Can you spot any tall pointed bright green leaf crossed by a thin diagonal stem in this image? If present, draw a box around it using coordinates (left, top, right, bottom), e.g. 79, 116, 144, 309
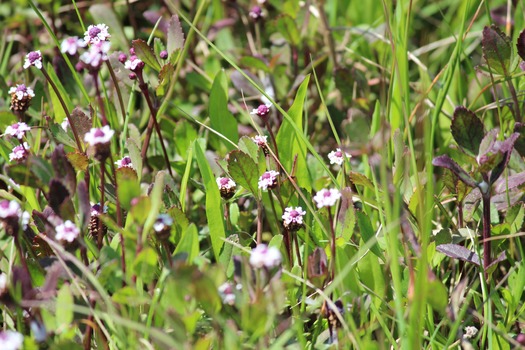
277, 75, 312, 191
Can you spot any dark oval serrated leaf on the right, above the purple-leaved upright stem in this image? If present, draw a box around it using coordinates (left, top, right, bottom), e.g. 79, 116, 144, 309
450, 106, 485, 156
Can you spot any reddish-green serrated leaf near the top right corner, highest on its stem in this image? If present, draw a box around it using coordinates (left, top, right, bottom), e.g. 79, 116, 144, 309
481, 25, 512, 76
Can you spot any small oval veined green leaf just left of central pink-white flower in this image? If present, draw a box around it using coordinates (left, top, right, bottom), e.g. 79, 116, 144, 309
228, 151, 259, 196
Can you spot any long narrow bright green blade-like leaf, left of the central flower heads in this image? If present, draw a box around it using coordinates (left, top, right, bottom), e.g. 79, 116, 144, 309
193, 140, 226, 260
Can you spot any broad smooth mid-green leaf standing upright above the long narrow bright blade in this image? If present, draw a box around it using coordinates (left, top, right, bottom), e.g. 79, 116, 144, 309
208, 70, 239, 151
